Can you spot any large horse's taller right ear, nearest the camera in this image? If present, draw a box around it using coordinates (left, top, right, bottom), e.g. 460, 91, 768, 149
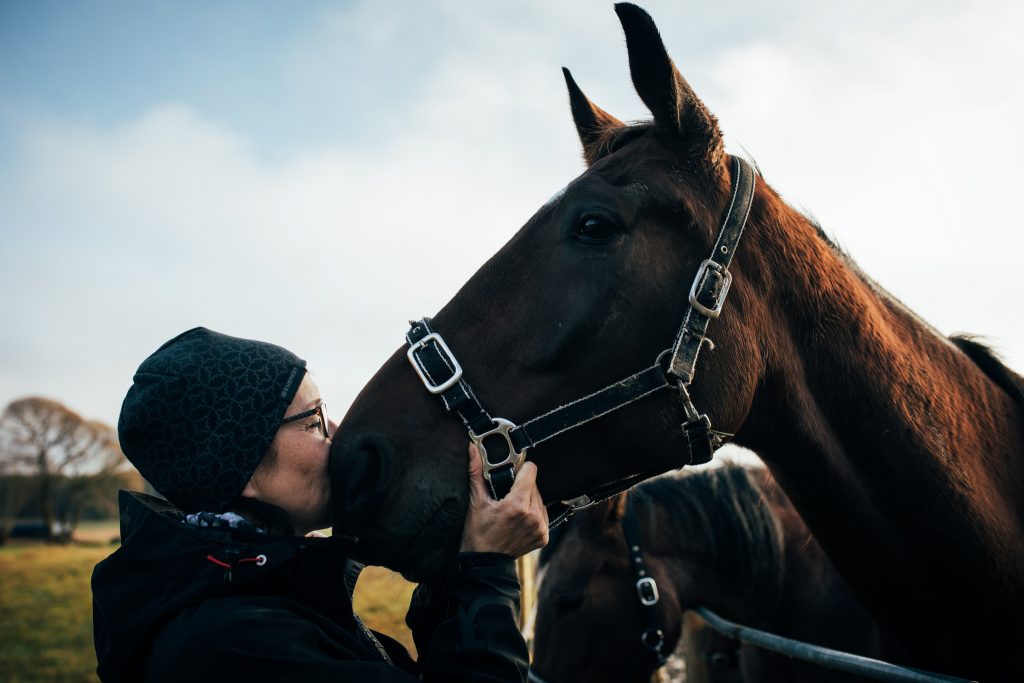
615, 2, 724, 166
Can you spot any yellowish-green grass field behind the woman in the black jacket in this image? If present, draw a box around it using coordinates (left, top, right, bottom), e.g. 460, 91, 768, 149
0, 522, 414, 683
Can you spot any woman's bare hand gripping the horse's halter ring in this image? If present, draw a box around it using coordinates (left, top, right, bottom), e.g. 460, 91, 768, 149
459, 443, 548, 557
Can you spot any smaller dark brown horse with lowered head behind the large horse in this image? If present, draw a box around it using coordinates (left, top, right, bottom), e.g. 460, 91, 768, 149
530, 466, 880, 683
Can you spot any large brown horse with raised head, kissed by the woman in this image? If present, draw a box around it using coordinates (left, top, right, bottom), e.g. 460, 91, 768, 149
332, 4, 1024, 680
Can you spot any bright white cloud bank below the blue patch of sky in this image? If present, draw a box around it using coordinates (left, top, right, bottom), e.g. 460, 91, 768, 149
0, 3, 1024, 428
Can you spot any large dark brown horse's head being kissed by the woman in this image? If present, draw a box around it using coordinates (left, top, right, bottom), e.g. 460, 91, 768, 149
332, 4, 764, 578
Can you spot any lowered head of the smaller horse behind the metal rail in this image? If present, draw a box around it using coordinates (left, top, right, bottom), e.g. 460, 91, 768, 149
530, 494, 683, 683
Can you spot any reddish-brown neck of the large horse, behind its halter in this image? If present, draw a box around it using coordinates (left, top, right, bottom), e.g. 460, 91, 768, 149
737, 208, 1024, 667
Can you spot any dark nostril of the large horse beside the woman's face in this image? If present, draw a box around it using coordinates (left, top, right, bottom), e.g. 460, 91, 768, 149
331, 439, 386, 535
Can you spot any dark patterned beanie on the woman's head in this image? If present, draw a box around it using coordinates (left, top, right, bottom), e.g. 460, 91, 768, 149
118, 328, 306, 512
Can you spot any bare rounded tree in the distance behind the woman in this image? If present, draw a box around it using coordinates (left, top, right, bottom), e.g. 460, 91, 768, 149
0, 396, 125, 540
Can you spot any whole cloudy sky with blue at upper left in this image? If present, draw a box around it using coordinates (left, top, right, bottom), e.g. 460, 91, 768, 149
0, 0, 1024, 424
